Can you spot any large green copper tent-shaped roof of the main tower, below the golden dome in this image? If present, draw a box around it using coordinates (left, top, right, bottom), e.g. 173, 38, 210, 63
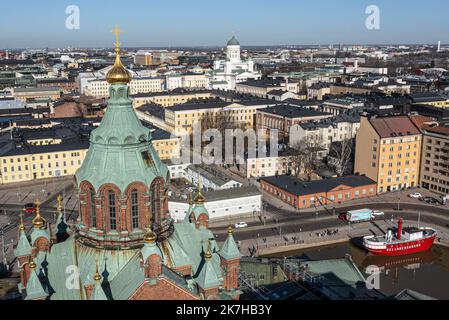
75, 85, 168, 192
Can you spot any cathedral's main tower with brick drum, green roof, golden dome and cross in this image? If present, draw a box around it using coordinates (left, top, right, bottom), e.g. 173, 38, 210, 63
75, 28, 169, 247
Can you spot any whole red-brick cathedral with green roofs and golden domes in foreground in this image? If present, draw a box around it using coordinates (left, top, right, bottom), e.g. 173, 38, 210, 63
14, 28, 241, 300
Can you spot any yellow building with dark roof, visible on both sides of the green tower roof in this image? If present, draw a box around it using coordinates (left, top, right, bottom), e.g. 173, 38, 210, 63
0, 122, 181, 184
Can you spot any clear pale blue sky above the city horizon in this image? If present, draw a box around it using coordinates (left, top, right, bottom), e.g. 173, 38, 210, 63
0, 0, 449, 49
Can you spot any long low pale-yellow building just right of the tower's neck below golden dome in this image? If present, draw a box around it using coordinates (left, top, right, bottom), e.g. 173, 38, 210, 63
131, 90, 211, 108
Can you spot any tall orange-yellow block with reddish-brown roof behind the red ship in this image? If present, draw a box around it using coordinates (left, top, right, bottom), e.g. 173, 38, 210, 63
354, 116, 422, 193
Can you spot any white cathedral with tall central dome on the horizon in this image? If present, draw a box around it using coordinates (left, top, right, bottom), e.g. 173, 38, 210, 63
208, 36, 262, 90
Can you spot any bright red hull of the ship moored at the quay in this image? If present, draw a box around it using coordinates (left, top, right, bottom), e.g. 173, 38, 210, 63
364, 235, 436, 256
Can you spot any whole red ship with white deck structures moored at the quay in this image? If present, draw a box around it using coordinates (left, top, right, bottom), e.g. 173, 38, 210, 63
363, 218, 437, 256
